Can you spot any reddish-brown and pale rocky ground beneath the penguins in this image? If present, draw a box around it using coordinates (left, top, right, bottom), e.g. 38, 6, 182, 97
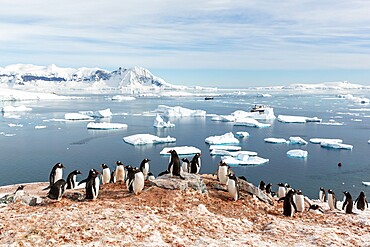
0, 175, 370, 246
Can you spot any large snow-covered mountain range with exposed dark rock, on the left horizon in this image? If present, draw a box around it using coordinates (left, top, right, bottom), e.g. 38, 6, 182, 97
0, 64, 186, 93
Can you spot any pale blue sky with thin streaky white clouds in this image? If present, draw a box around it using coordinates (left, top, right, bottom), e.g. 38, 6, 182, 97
0, 0, 370, 87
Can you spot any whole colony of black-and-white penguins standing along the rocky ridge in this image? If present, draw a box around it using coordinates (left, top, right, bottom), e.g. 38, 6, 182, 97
39, 153, 368, 216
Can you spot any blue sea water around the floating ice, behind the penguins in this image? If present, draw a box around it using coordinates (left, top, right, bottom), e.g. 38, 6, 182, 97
0, 94, 370, 198
